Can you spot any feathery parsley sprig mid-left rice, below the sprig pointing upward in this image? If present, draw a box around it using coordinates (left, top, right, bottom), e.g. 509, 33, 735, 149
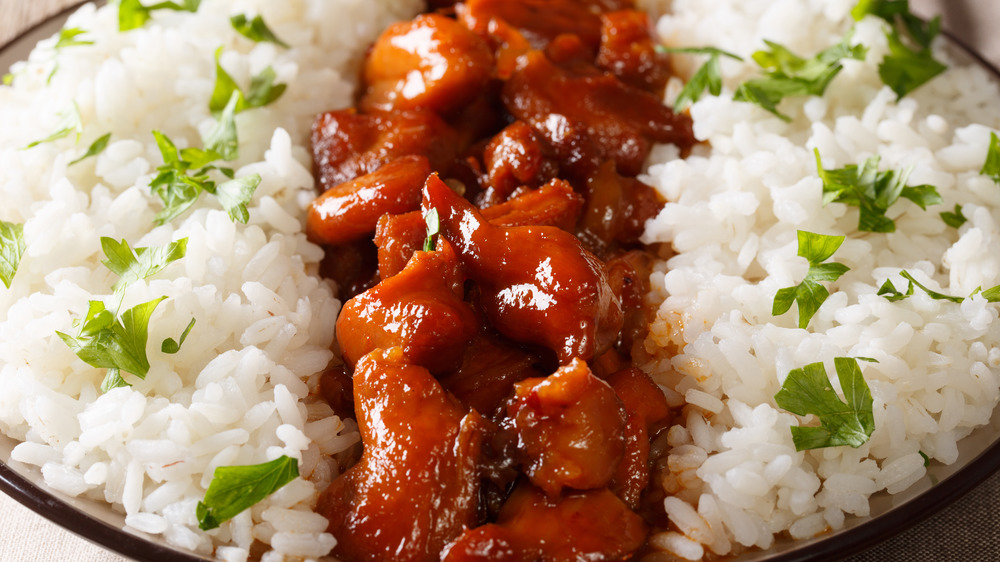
149, 131, 261, 224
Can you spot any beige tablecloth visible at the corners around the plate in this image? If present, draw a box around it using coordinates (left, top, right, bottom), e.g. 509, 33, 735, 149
0, 0, 1000, 562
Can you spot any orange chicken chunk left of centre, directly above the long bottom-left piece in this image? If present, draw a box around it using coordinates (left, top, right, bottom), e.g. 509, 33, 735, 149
337, 243, 479, 373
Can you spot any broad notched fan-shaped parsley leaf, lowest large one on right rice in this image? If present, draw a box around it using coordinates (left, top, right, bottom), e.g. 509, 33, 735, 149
774, 357, 875, 451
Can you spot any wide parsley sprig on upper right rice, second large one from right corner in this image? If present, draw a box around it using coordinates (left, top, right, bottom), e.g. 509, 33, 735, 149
733, 33, 868, 121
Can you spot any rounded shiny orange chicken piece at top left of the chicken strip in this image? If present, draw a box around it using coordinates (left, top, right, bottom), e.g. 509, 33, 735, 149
361, 14, 493, 115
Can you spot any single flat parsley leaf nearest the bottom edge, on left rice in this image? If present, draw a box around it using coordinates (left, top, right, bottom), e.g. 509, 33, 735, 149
195, 455, 299, 531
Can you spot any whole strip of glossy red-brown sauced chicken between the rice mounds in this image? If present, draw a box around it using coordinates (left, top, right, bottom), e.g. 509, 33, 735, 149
307, 0, 695, 562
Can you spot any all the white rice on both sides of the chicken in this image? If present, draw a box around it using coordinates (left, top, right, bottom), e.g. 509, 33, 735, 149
0, 0, 1000, 560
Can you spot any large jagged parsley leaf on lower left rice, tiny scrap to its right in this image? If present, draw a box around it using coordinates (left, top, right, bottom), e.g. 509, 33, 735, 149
56, 297, 166, 392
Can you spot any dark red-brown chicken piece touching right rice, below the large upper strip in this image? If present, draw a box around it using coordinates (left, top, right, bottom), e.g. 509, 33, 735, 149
578, 161, 666, 257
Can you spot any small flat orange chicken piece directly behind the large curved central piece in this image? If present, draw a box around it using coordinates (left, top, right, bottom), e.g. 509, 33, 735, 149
482, 179, 583, 232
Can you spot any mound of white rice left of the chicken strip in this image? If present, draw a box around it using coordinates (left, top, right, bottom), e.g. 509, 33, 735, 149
0, 0, 421, 560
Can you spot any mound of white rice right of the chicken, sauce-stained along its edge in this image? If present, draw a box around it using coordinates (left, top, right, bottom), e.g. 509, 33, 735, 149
645, 0, 1000, 560
